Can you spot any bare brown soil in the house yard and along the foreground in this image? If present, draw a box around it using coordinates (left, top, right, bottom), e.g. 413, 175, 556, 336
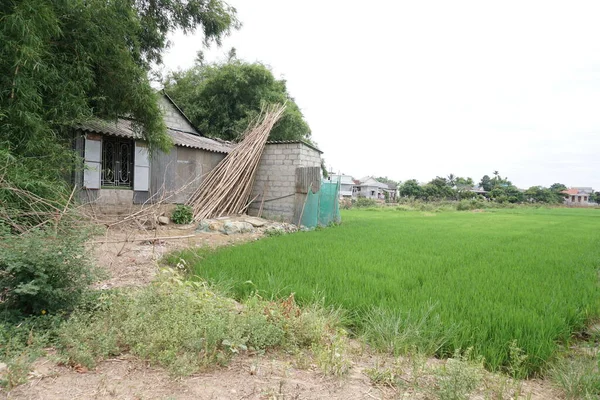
0, 220, 562, 400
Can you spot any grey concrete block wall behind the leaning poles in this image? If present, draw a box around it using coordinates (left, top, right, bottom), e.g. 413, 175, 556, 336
248, 143, 321, 223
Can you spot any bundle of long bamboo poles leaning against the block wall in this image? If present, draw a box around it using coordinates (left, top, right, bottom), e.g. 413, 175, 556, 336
186, 105, 285, 221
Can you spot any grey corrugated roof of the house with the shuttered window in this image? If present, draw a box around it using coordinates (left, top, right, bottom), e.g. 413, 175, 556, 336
77, 118, 234, 153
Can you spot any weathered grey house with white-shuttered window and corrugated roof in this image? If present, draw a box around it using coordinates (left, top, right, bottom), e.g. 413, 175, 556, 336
73, 93, 233, 211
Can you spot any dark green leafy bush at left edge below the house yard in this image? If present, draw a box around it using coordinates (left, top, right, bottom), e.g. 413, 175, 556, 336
0, 225, 96, 315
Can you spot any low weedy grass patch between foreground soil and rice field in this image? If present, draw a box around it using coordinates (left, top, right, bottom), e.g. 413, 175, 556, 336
58, 272, 346, 376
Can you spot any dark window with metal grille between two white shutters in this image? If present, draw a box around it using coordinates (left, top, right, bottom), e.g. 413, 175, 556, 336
102, 136, 133, 187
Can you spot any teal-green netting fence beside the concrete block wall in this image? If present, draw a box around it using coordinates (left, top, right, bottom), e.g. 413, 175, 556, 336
301, 182, 342, 228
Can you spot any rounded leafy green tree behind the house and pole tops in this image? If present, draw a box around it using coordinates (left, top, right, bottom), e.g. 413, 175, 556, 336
164, 52, 311, 140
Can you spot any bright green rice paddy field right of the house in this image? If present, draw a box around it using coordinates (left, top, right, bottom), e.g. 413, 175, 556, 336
182, 208, 600, 375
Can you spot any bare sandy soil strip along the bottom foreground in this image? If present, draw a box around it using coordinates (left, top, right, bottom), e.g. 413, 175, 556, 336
0, 354, 562, 400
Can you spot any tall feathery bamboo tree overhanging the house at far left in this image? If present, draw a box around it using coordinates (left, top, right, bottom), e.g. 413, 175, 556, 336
0, 0, 239, 225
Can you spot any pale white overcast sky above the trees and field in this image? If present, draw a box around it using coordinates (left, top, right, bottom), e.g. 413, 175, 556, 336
163, 0, 600, 190
